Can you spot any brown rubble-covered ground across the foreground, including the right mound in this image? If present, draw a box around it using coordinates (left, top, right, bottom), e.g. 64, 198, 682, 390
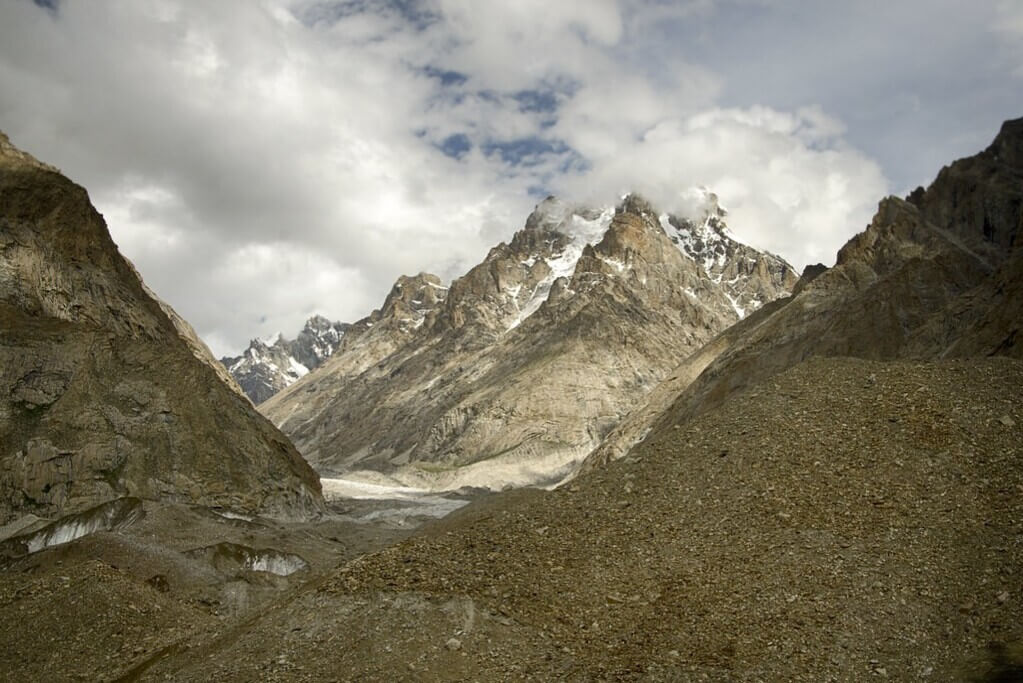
0, 358, 1023, 681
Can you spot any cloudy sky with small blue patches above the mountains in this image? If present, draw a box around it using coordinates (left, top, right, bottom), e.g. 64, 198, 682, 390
0, 0, 1023, 355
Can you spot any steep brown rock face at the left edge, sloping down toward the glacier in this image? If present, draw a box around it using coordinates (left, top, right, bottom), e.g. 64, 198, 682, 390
0, 130, 322, 519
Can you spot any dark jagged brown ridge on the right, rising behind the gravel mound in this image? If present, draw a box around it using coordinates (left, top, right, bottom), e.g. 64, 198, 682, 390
586, 114, 1023, 467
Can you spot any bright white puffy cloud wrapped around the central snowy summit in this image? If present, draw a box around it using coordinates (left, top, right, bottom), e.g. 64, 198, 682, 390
562, 106, 887, 268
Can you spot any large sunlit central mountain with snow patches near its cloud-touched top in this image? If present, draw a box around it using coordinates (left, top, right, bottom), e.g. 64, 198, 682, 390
261, 191, 796, 489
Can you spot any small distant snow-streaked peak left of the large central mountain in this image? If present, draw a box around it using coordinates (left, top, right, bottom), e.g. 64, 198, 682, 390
221, 316, 349, 405
